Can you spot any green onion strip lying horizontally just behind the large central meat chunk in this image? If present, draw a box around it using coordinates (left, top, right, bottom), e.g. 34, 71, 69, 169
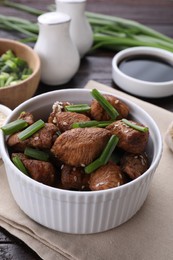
72, 120, 112, 128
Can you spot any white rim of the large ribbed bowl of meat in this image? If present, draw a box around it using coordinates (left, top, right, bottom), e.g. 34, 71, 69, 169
0, 88, 163, 197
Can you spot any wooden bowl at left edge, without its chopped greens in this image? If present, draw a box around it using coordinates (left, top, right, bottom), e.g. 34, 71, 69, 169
0, 38, 40, 109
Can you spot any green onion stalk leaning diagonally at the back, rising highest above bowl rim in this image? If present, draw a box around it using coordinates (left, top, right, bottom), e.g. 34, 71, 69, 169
91, 89, 119, 120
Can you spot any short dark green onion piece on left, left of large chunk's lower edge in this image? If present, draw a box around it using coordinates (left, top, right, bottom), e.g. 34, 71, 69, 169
24, 147, 49, 162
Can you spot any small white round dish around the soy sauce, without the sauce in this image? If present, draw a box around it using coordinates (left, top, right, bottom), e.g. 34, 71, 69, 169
112, 47, 173, 98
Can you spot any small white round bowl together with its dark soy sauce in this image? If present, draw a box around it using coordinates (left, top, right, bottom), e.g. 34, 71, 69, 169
112, 47, 173, 98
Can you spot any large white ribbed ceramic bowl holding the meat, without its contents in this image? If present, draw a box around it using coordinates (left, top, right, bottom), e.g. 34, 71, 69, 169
0, 89, 162, 234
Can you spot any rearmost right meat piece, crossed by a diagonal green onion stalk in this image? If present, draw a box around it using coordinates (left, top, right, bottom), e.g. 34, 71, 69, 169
91, 95, 129, 121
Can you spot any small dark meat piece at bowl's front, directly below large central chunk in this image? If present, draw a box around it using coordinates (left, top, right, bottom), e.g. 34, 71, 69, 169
61, 164, 90, 190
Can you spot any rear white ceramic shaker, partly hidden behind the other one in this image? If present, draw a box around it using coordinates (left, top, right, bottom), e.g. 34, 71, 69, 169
56, 0, 93, 57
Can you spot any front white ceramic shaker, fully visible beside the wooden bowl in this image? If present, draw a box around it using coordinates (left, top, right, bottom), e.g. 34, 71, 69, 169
34, 12, 80, 85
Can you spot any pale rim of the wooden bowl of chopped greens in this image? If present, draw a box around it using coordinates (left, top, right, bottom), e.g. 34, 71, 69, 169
0, 38, 41, 91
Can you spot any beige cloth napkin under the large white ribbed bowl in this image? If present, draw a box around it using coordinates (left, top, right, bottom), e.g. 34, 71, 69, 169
0, 81, 173, 260
